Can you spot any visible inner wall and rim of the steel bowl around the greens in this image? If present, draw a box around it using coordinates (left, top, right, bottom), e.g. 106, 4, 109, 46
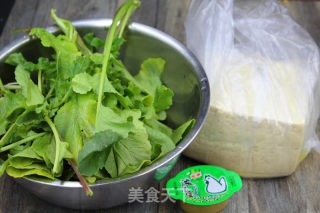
0, 20, 209, 186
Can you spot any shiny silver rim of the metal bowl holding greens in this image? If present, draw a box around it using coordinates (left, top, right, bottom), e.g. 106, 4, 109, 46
0, 19, 210, 188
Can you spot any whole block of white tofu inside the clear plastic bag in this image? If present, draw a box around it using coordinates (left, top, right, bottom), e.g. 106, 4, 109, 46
184, 57, 317, 177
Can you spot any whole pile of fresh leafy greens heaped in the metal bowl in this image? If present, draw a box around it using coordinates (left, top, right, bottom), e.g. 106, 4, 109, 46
0, 0, 194, 195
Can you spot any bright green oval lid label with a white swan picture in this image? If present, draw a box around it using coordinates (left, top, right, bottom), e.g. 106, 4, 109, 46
167, 165, 242, 205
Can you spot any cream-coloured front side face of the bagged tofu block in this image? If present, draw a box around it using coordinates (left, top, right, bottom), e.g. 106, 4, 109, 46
184, 107, 304, 177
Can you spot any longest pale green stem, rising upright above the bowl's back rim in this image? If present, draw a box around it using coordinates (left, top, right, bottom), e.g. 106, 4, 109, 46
96, 0, 140, 126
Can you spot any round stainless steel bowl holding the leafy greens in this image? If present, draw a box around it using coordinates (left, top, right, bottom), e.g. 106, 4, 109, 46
0, 19, 210, 209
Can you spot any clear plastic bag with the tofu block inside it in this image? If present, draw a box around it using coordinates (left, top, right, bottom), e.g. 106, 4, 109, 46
184, 0, 320, 177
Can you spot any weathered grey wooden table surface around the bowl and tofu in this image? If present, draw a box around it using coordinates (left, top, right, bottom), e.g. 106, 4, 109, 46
0, 0, 320, 213
